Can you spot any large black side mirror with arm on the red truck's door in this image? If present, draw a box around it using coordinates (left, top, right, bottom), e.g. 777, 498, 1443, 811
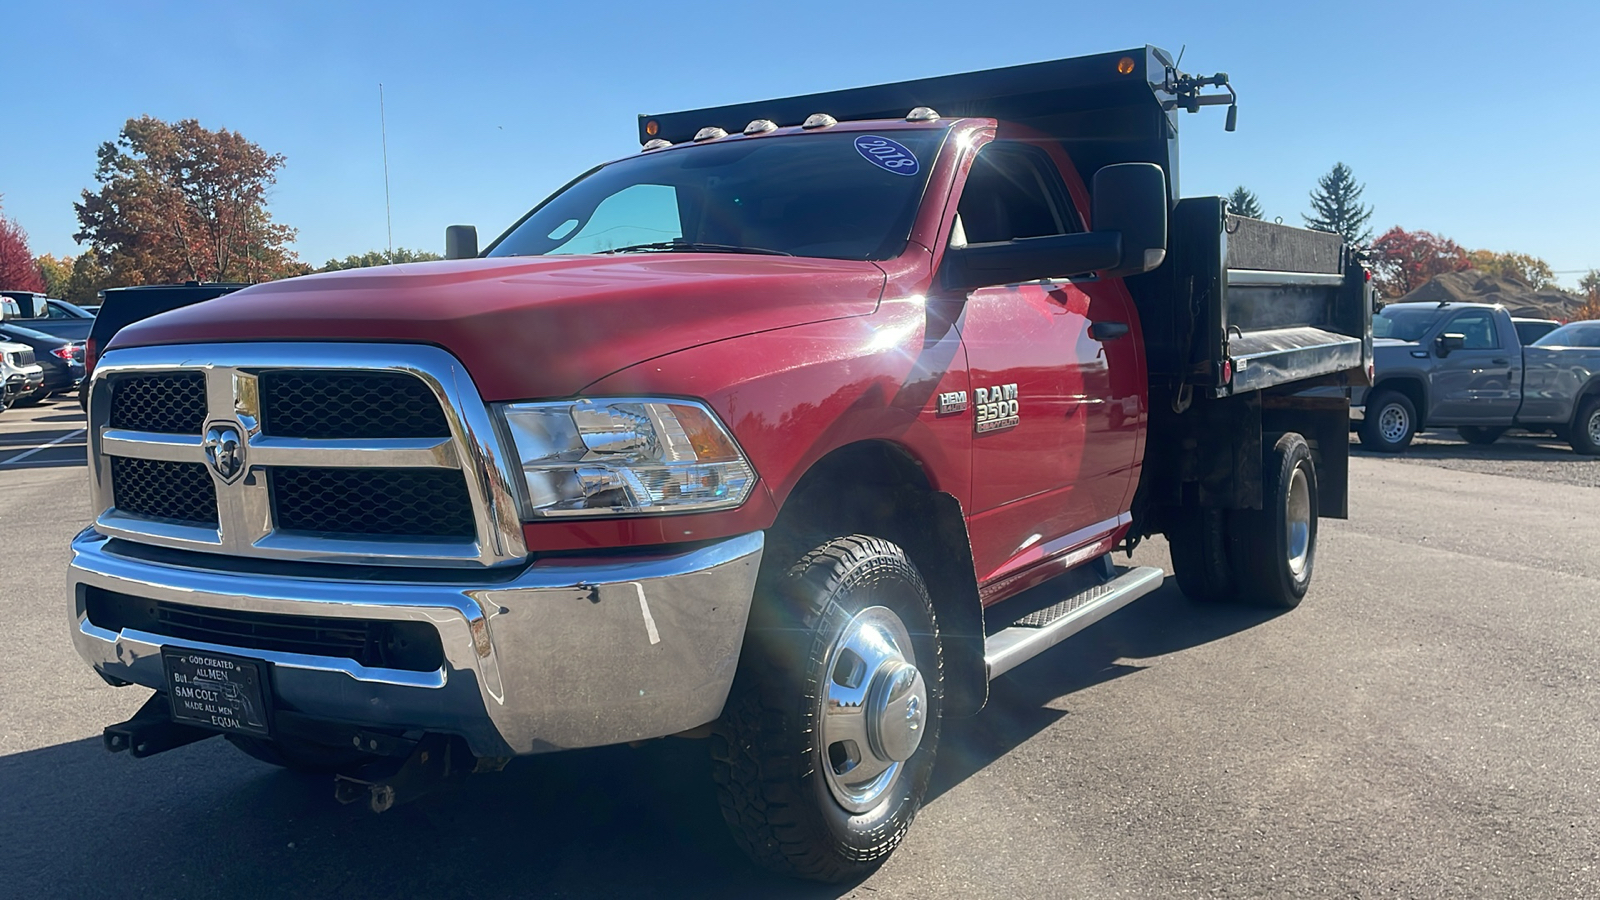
941, 162, 1166, 290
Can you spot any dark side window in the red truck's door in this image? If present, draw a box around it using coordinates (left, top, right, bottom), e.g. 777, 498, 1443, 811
952, 141, 1083, 243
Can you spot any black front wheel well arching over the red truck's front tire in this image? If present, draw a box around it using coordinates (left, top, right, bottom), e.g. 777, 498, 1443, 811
762, 440, 989, 716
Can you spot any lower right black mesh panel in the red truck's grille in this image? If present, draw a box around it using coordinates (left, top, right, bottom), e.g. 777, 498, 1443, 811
270, 466, 477, 540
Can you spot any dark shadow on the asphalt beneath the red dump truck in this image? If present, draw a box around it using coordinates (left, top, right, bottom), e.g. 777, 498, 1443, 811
0, 585, 1269, 900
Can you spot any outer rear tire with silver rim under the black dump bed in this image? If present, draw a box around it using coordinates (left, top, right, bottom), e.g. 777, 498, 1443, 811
1229, 432, 1318, 609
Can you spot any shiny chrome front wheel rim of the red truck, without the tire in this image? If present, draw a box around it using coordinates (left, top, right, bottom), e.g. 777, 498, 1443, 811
816, 607, 928, 814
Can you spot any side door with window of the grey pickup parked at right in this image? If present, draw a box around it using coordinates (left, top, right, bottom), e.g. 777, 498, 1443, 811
1429, 309, 1522, 424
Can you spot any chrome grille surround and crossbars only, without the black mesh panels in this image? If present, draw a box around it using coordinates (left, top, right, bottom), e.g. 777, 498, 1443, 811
86, 343, 528, 567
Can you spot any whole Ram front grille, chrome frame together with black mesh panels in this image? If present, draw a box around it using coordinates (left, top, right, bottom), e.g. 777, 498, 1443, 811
88, 343, 526, 565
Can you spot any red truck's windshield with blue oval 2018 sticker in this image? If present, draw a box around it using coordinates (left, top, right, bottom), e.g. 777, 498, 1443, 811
486, 130, 946, 259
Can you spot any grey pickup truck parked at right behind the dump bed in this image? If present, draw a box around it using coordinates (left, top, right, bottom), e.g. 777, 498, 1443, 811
1350, 303, 1600, 455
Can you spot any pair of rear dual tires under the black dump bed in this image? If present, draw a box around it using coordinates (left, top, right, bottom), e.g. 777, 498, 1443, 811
1166, 432, 1320, 609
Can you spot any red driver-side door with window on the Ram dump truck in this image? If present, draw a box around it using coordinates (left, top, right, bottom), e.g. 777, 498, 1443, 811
952, 141, 1144, 580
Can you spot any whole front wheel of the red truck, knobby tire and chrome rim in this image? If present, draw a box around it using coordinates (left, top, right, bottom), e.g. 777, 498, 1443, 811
712, 535, 944, 882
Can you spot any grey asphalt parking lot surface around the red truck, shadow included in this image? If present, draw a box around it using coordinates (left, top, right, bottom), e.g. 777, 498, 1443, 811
0, 400, 1600, 900
